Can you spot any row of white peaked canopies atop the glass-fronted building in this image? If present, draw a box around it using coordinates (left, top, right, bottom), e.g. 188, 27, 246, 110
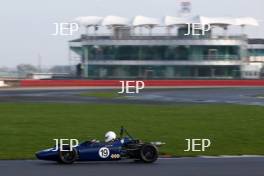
74, 15, 259, 27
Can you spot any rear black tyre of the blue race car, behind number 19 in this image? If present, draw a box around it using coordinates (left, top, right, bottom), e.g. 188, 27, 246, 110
140, 144, 159, 163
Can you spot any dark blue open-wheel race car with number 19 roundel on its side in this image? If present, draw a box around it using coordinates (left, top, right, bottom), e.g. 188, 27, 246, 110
36, 127, 164, 164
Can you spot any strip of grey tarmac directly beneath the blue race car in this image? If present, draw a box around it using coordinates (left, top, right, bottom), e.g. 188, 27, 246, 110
0, 157, 264, 176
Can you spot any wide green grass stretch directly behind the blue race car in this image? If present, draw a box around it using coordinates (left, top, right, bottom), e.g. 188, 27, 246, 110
0, 103, 264, 159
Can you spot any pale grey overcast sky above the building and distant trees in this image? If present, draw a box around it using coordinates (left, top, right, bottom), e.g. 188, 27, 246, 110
0, 0, 264, 67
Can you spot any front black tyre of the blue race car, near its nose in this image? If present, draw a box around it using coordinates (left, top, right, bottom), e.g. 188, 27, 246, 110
59, 147, 77, 164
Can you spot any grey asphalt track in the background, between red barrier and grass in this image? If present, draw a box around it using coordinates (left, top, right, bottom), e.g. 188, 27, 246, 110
0, 87, 264, 106
